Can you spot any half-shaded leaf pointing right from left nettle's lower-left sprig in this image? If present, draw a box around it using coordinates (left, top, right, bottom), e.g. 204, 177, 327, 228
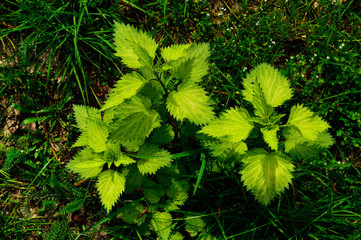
137, 144, 172, 174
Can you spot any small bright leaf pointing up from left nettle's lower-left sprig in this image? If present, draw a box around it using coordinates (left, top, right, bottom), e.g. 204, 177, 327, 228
85, 119, 109, 152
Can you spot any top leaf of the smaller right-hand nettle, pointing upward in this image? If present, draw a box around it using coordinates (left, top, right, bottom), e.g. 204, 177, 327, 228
243, 63, 292, 107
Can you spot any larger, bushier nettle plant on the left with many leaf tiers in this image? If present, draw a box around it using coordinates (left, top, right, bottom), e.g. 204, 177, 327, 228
67, 23, 215, 240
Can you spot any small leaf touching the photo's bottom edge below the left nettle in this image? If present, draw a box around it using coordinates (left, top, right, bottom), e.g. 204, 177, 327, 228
150, 212, 172, 240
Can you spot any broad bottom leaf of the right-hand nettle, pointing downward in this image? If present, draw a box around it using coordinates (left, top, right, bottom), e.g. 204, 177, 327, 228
240, 149, 294, 205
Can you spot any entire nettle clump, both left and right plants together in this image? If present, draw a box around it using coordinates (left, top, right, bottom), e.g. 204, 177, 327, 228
67, 23, 332, 240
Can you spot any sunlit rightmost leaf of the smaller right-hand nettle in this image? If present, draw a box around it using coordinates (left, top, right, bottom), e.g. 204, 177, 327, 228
287, 105, 330, 140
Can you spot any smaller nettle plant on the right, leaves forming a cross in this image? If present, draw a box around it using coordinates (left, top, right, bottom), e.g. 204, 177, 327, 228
200, 63, 333, 205
